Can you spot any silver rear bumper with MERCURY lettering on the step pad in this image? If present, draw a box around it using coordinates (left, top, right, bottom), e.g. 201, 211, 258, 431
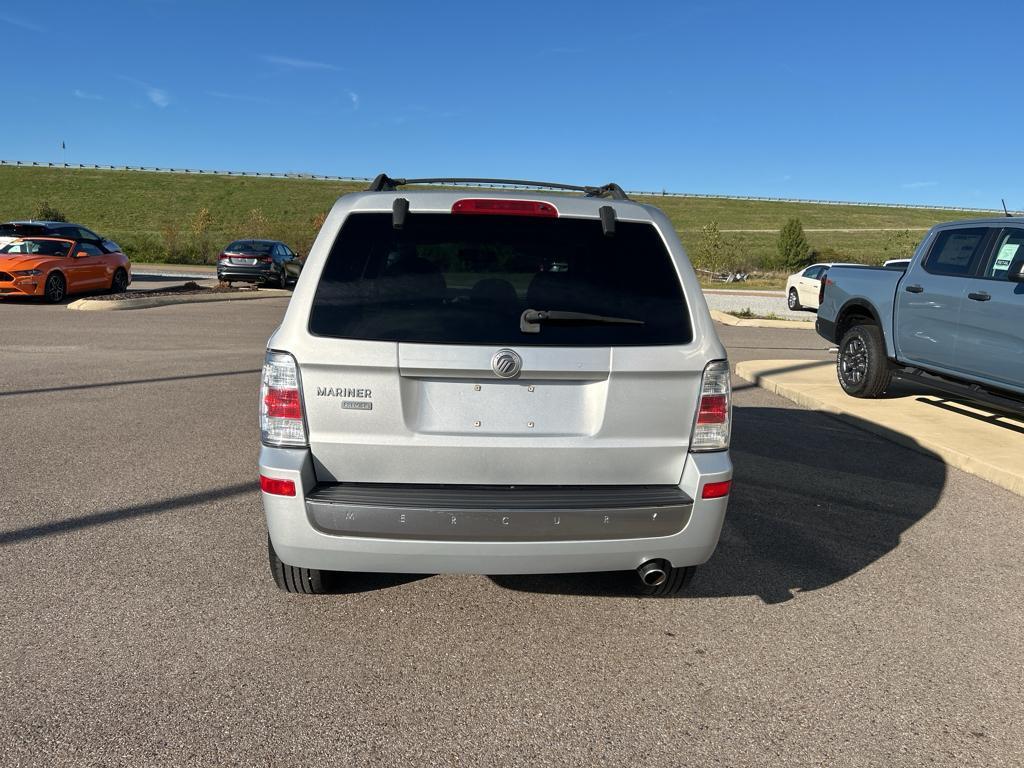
260, 446, 732, 574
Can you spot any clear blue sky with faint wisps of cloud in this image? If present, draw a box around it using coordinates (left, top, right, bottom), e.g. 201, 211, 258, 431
0, 0, 1024, 208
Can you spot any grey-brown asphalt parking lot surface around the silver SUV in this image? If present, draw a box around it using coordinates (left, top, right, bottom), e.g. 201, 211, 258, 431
0, 299, 1024, 766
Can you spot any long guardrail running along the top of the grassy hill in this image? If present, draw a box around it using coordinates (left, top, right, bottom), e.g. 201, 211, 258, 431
0, 160, 1024, 215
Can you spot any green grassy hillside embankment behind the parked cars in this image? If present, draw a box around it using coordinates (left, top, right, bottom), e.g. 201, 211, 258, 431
0, 166, 991, 268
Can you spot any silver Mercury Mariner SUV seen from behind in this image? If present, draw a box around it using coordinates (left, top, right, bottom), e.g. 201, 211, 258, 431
259, 175, 732, 595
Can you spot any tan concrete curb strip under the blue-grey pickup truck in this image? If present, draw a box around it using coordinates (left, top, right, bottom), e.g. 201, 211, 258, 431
736, 359, 1024, 496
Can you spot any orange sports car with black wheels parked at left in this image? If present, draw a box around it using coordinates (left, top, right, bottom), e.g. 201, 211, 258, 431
0, 238, 131, 303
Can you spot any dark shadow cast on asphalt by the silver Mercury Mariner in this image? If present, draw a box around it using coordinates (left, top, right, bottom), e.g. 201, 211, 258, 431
492, 407, 947, 603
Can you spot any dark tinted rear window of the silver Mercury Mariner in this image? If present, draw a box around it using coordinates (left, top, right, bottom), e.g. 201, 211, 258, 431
309, 208, 692, 346
